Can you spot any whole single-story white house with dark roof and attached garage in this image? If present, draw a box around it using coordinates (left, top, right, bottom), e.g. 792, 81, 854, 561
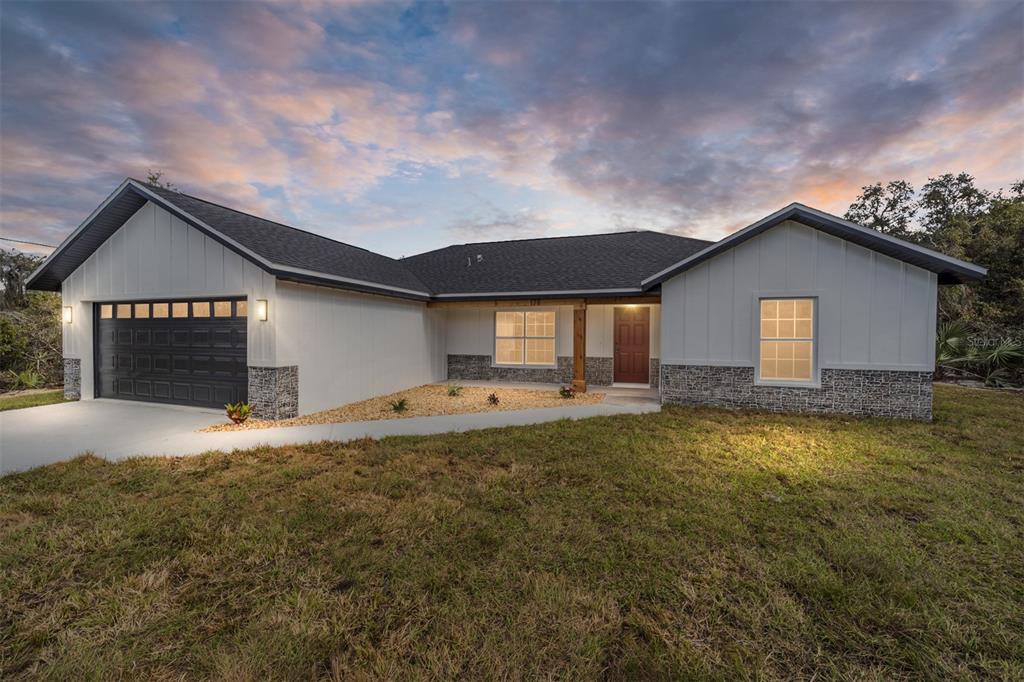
29, 179, 985, 420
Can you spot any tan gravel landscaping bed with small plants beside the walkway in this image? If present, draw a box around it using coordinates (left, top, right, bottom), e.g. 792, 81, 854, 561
201, 384, 604, 432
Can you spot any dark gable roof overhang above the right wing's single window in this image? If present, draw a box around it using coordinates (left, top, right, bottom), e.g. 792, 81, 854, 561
643, 204, 987, 289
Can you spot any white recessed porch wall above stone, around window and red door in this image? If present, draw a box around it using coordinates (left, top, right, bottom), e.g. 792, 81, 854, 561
446, 305, 660, 357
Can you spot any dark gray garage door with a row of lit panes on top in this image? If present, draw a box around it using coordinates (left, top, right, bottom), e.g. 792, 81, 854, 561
95, 298, 248, 408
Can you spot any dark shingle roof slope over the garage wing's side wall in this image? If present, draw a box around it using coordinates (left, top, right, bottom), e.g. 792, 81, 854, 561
145, 185, 428, 293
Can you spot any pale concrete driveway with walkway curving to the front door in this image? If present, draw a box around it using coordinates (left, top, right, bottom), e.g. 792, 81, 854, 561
0, 382, 660, 474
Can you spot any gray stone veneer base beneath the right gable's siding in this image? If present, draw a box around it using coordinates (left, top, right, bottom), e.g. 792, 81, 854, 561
660, 365, 932, 421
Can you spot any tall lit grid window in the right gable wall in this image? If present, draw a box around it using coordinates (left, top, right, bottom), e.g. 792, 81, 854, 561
760, 298, 814, 381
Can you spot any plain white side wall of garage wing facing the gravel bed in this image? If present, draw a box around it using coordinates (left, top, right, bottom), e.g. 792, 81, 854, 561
274, 282, 446, 415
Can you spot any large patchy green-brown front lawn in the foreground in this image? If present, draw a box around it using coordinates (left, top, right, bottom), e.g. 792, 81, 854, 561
0, 387, 1024, 680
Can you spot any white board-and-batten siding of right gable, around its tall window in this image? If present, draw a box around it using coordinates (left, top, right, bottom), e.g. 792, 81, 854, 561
662, 221, 938, 372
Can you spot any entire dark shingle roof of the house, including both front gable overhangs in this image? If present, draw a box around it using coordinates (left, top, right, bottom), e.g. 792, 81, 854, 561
28, 179, 985, 299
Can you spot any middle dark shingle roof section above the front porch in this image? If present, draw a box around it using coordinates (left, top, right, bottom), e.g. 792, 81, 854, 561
401, 231, 712, 295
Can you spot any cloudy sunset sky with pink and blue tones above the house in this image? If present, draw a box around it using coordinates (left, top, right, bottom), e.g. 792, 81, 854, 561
0, 0, 1024, 257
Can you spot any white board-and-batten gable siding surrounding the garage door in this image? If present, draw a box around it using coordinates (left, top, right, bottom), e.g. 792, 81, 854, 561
60, 203, 276, 398
